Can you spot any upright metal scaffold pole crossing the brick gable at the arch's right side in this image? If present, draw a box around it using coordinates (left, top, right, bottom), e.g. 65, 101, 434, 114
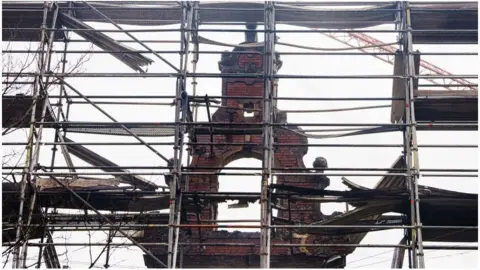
260, 1, 275, 268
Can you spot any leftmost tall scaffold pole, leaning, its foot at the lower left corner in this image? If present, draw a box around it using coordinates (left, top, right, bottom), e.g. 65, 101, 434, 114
12, 2, 48, 268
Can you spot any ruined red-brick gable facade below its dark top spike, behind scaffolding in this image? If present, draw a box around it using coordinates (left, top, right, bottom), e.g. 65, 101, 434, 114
143, 39, 349, 268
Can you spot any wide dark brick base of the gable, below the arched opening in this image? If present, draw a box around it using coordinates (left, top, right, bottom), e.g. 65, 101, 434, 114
144, 230, 347, 268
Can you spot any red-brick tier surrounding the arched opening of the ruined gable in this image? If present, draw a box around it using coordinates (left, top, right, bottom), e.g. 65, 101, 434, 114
188, 129, 315, 225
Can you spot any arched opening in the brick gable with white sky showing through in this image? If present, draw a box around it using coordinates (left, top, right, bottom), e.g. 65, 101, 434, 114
217, 158, 262, 232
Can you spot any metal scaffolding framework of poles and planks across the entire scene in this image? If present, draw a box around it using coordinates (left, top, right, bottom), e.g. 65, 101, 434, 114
2, 1, 478, 268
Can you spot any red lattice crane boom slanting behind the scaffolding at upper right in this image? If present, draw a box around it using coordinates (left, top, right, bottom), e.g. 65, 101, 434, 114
323, 33, 477, 90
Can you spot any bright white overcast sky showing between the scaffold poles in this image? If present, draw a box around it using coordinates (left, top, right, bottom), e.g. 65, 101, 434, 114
2, 3, 478, 268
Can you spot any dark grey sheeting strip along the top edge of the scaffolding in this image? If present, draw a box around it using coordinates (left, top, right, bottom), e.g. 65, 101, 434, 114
2, 1, 478, 43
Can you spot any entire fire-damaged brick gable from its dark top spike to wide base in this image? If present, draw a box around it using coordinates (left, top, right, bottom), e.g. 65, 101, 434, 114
142, 25, 353, 268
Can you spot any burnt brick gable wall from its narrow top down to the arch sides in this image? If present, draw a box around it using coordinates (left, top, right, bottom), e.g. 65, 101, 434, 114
184, 45, 314, 225
